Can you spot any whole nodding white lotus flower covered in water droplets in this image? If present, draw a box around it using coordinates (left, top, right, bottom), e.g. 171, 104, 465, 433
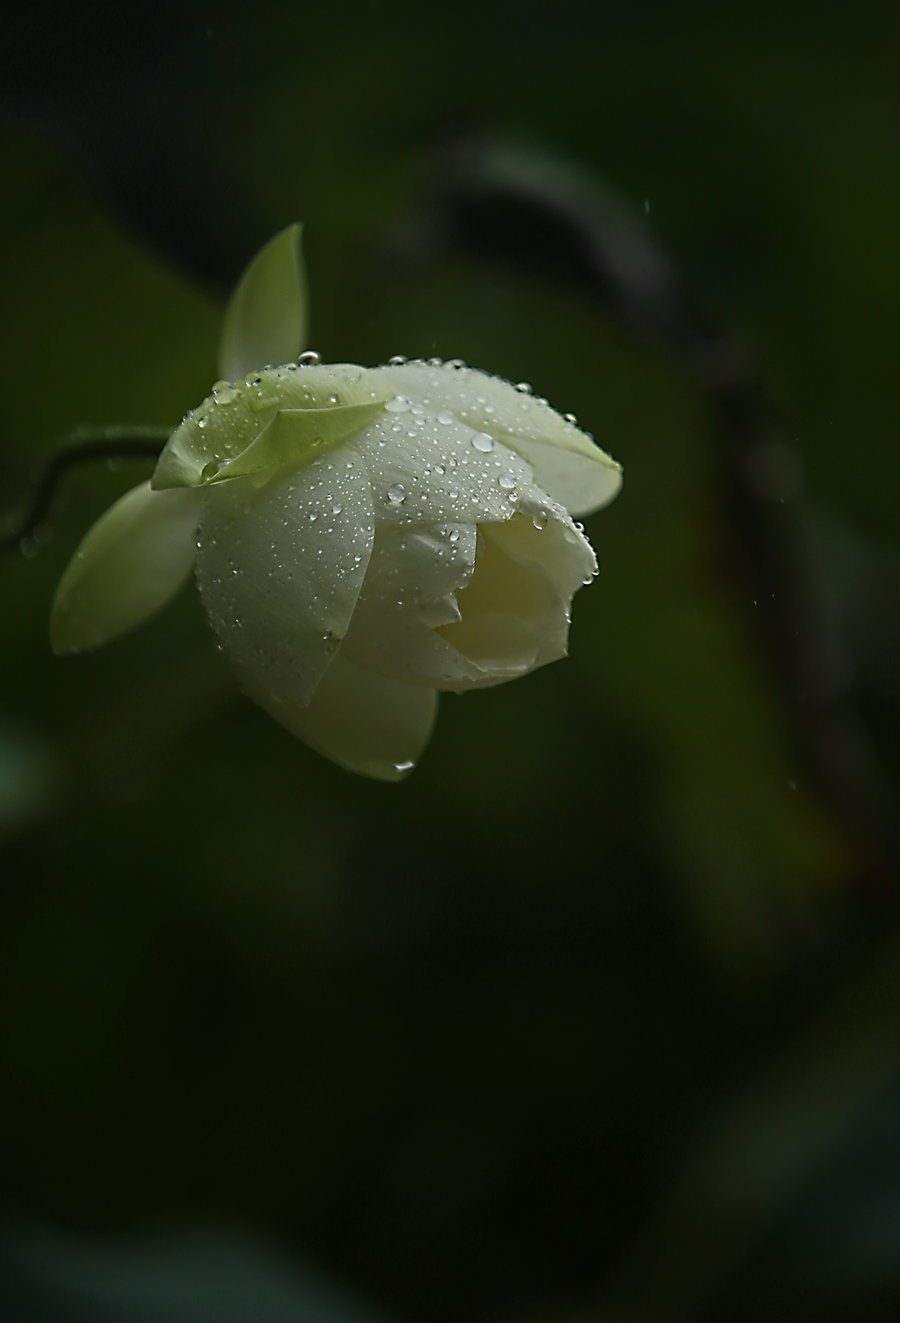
52, 226, 621, 781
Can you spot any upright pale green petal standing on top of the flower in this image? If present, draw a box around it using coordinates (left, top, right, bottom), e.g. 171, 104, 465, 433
218, 225, 307, 381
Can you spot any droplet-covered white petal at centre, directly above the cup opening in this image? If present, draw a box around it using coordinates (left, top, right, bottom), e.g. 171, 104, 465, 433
347, 402, 533, 524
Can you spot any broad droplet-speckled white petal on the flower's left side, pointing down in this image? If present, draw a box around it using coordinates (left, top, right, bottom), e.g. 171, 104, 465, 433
197, 450, 375, 704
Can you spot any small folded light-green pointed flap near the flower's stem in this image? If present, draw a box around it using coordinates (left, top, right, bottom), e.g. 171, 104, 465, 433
209, 402, 384, 483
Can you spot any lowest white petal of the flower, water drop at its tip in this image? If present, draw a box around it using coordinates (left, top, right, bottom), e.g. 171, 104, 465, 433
236, 654, 437, 781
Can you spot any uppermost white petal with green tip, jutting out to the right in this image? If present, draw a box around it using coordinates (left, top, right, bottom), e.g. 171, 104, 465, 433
372, 363, 622, 515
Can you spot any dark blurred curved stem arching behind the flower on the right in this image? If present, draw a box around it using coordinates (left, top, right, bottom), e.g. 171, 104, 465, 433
418, 138, 897, 886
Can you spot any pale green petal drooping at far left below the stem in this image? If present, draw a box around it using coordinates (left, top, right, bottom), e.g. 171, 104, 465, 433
50, 483, 200, 652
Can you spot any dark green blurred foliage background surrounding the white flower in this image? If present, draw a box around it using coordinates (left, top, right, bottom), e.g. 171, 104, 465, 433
0, 0, 900, 1323
